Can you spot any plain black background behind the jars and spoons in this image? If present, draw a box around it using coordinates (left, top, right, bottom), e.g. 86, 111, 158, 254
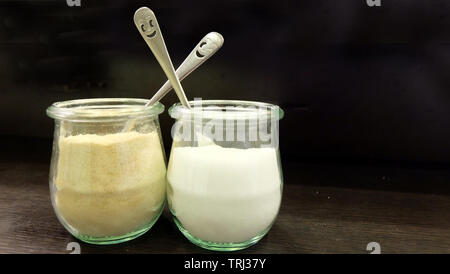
0, 0, 450, 188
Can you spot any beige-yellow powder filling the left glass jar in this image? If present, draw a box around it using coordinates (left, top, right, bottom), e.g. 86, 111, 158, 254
55, 132, 166, 237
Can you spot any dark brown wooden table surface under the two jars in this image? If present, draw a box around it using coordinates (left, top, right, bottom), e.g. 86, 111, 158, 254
0, 161, 450, 253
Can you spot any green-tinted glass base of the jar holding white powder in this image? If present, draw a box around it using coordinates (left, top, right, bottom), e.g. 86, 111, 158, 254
173, 217, 270, 251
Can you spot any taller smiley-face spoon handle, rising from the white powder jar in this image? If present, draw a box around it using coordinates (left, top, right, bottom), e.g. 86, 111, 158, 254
134, 7, 190, 108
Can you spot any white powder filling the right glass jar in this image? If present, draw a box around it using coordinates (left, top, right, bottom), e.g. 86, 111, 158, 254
167, 145, 281, 243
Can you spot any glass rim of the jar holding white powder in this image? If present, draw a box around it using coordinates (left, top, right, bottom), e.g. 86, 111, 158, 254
169, 100, 284, 120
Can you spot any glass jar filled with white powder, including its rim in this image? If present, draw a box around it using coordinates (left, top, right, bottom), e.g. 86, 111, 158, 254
167, 100, 283, 251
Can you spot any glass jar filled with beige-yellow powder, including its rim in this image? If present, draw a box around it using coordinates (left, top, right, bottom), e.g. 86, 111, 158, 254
47, 98, 166, 244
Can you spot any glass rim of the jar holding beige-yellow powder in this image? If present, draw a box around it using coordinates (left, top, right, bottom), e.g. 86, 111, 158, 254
46, 98, 164, 122
